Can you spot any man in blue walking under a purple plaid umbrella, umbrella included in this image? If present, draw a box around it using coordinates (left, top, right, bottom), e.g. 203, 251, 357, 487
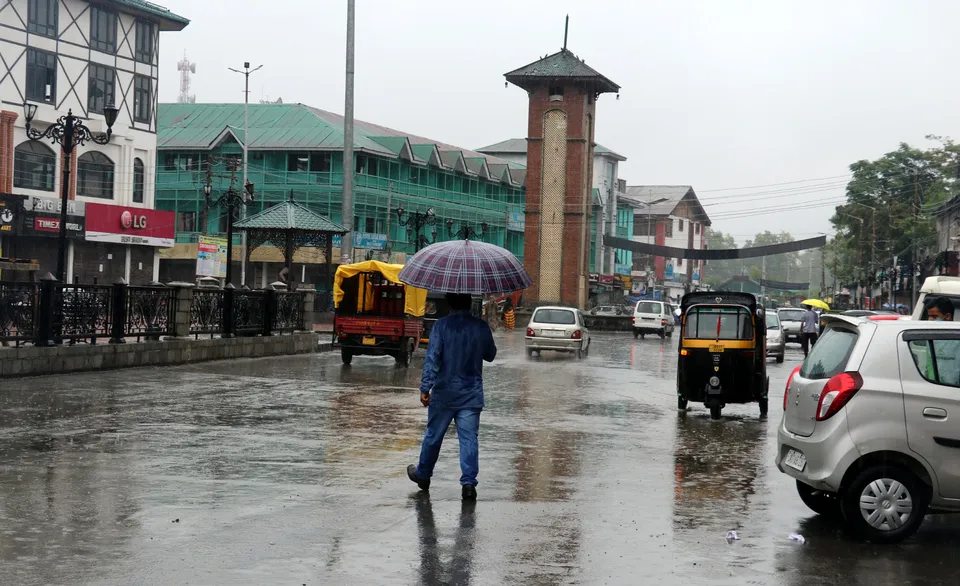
400, 240, 533, 500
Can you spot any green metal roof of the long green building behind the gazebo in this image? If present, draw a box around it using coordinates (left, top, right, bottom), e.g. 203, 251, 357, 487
157, 104, 524, 174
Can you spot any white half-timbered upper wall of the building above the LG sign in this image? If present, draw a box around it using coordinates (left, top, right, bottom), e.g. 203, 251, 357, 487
0, 0, 169, 208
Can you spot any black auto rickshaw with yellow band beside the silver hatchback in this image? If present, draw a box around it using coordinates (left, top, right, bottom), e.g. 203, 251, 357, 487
677, 291, 770, 419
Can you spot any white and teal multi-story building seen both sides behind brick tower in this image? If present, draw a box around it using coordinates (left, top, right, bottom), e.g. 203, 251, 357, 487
477, 138, 633, 277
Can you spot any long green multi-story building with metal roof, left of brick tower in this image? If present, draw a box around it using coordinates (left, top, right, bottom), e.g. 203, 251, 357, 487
157, 104, 526, 288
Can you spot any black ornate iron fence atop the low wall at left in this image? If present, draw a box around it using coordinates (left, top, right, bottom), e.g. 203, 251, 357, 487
0, 275, 313, 346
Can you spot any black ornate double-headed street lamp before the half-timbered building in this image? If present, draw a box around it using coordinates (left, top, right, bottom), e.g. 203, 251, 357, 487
23, 102, 120, 283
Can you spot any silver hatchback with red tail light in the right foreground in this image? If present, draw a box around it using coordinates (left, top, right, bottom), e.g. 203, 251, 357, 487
776, 316, 960, 543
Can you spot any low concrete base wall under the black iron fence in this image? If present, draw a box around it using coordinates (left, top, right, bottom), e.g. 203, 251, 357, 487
0, 332, 331, 378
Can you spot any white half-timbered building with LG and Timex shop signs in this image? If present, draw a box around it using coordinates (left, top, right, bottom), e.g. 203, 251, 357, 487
0, 0, 189, 282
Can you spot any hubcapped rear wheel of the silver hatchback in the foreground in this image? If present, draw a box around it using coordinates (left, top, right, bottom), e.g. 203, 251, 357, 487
840, 465, 930, 543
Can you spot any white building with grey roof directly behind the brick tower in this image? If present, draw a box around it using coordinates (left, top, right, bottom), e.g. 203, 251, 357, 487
477, 138, 627, 275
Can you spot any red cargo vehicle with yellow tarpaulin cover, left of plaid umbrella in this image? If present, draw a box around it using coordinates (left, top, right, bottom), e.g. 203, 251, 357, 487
333, 260, 427, 367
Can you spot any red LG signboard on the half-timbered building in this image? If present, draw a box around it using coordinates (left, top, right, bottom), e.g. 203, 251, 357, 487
87, 203, 176, 248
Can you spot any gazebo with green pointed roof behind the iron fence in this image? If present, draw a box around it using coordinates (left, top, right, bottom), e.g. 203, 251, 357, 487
234, 194, 347, 287
